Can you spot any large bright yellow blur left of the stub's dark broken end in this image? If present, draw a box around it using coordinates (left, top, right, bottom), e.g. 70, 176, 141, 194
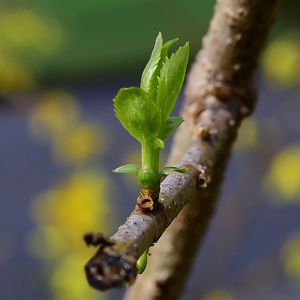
28, 170, 112, 300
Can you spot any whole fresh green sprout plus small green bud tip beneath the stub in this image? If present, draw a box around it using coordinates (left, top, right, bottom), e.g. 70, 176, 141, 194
113, 33, 189, 271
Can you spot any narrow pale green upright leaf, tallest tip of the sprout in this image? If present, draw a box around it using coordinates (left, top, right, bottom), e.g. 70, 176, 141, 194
141, 33, 163, 92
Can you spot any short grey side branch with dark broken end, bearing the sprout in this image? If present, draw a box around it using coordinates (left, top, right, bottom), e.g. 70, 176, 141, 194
85, 147, 212, 290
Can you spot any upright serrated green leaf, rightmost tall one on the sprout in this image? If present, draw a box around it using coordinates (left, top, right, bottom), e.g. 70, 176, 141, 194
156, 43, 189, 123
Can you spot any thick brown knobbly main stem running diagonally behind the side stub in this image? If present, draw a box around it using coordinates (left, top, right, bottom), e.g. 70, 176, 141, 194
126, 0, 278, 300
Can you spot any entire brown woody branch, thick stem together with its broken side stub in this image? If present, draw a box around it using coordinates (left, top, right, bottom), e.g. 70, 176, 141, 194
85, 0, 277, 292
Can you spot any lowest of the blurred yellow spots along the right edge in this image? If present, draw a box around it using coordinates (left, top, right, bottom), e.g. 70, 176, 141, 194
281, 234, 300, 280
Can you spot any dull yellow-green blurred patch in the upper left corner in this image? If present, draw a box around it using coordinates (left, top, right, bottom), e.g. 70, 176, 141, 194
0, 3, 64, 93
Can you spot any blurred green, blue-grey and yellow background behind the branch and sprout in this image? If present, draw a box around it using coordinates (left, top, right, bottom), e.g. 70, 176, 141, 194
0, 0, 300, 300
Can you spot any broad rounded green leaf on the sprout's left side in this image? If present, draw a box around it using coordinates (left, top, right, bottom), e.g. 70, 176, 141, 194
113, 87, 161, 143
